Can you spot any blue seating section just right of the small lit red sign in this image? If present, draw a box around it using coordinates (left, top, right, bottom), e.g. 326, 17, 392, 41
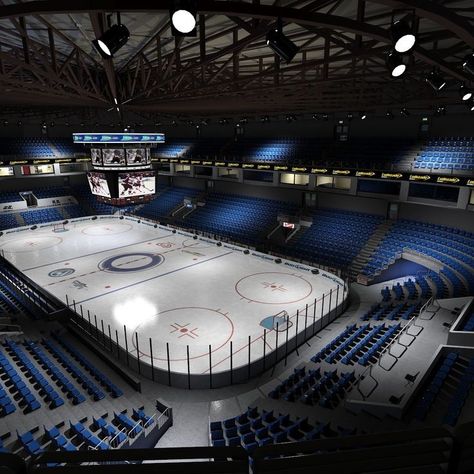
285, 209, 383, 267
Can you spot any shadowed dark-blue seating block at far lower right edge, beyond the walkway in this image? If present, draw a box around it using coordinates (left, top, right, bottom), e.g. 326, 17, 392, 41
414, 352, 474, 426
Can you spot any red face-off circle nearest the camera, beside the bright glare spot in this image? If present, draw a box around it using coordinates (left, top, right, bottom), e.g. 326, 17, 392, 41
132, 306, 234, 362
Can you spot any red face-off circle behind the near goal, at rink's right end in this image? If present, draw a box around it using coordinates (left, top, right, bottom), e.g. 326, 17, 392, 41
235, 272, 313, 304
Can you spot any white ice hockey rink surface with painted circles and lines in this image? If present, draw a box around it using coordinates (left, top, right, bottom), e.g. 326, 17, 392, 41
0, 216, 345, 380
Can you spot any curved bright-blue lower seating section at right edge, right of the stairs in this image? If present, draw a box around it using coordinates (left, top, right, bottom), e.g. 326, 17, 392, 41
362, 220, 474, 296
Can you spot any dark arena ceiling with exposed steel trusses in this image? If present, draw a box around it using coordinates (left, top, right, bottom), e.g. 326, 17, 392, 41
0, 0, 474, 121
